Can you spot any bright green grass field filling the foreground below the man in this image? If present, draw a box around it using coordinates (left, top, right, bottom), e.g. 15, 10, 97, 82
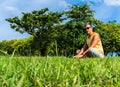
0, 56, 120, 87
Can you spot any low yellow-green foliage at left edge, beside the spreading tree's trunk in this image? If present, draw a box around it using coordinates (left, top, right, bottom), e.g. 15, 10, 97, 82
0, 37, 33, 56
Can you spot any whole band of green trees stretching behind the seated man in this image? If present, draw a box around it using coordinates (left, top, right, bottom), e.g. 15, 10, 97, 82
0, 4, 120, 56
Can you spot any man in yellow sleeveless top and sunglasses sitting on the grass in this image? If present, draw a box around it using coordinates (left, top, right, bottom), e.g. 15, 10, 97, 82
74, 24, 104, 58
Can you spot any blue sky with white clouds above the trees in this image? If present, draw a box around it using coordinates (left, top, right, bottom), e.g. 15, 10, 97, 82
0, 0, 120, 41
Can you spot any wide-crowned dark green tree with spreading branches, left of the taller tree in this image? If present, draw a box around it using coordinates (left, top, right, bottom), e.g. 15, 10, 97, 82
6, 8, 63, 55
